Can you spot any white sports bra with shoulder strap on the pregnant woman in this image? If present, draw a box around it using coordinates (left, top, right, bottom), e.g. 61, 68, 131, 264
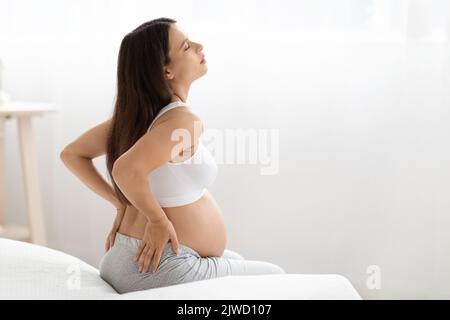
147, 100, 218, 208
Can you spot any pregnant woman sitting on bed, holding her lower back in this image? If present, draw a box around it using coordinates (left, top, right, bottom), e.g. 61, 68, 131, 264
61, 18, 285, 293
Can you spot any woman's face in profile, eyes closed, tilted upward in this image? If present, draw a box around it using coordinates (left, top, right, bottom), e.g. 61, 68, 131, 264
165, 23, 208, 84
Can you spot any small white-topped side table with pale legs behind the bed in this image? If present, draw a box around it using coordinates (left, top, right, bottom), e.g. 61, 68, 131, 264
0, 101, 59, 245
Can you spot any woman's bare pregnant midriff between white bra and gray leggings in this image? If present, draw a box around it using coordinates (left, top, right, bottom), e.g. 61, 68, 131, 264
118, 190, 227, 257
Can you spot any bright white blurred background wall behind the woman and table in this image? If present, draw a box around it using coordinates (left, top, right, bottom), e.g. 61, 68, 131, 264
0, 0, 450, 299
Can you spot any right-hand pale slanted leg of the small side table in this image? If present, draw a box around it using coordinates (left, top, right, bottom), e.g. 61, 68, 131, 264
17, 116, 46, 245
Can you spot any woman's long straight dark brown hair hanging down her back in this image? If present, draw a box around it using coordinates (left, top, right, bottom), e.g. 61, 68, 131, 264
106, 18, 177, 205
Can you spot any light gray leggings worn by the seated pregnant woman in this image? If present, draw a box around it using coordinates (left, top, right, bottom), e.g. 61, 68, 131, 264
99, 232, 286, 293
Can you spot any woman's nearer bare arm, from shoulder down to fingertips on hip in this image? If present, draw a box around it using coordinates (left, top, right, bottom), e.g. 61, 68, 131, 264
112, 113, 200, 272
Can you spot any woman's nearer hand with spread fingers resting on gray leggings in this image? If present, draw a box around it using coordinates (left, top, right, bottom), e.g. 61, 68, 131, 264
134, 219, 179, 272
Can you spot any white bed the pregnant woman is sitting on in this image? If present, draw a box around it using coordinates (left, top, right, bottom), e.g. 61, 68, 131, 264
0, 238, 362, 300
